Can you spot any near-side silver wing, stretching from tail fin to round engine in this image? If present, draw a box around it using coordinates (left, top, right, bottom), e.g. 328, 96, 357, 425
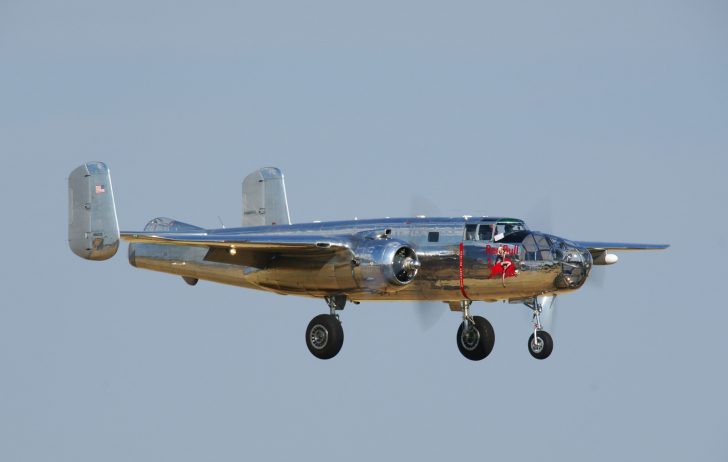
121, 231, 353, 268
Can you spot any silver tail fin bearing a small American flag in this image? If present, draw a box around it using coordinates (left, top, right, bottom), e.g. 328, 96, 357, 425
68, 162, 119, 260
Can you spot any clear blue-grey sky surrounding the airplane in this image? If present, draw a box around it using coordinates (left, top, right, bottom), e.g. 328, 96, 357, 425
0, 0, 728, 462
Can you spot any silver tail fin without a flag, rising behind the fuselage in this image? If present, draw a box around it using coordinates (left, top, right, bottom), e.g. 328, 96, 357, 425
243, 167, 291, 226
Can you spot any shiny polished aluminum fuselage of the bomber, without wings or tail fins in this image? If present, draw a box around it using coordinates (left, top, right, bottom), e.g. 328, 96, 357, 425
129, 218, 591, 302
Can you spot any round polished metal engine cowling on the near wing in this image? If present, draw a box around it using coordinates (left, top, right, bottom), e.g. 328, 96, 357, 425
353, 239, 420, 292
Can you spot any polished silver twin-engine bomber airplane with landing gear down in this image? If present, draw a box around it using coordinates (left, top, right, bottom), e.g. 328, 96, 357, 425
68, 162, 668, 361
